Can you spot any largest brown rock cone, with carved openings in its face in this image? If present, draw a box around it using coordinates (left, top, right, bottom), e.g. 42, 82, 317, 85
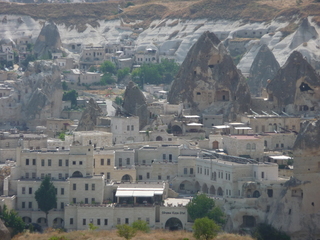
168, 32, 251, 119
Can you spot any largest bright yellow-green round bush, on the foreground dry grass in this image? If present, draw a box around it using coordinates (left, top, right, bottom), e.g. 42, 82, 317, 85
192, 217, 220, 240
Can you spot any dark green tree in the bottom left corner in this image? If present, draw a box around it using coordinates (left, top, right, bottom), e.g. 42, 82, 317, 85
0, 205, 25, 235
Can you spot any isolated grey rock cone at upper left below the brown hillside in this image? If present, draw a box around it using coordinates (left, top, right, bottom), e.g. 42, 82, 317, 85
33, 22, 62, 58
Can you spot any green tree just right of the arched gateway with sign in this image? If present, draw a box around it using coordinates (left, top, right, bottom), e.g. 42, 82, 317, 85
187, 194, 225, 225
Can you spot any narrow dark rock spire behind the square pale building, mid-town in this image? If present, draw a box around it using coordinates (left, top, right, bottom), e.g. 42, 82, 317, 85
122, 82, 149, 129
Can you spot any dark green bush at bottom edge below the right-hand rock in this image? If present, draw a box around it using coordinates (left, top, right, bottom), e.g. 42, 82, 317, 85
253, 223, 291, 240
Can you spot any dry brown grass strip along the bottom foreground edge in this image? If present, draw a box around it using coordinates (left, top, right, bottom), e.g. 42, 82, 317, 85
12, 230, 253, 240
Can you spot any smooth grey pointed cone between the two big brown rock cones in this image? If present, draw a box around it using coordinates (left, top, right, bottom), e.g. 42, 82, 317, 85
247, 44, 280, 96
